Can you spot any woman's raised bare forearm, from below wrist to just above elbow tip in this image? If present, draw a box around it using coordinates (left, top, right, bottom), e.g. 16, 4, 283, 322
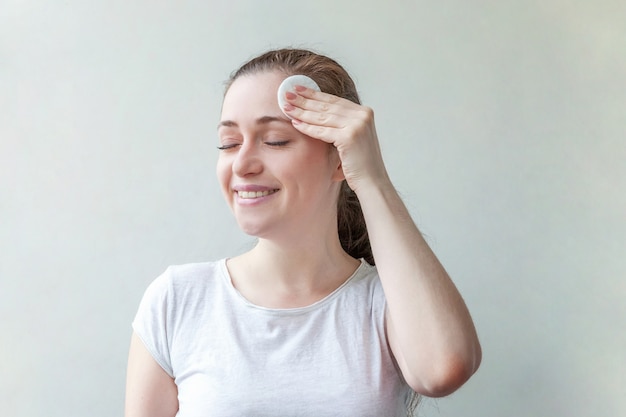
359, 181, 480, 394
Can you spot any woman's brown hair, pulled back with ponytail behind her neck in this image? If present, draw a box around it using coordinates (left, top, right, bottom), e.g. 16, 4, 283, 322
226, 49, 374, 265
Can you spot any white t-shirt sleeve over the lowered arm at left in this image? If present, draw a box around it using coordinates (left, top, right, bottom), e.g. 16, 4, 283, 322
132, 269, 174, 378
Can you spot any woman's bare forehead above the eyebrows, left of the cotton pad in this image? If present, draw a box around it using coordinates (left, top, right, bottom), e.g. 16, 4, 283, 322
222, 72, 286, 120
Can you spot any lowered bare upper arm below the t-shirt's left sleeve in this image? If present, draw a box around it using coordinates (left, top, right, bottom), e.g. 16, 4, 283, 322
124, 333, 178, 417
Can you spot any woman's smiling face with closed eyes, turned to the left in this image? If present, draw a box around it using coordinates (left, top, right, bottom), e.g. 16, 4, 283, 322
217, 72, 343, 238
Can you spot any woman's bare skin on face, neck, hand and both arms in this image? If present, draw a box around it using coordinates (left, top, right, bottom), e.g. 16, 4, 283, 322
125, 72, 481, 417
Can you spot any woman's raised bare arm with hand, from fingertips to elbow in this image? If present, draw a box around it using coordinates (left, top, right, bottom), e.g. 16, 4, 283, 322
285, 87, 482, 396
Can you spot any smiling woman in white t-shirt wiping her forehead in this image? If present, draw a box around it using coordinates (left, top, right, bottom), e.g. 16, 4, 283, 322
126, 49, 481, 417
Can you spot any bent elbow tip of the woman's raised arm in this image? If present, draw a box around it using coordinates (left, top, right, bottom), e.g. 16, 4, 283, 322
405, 347, 482, 397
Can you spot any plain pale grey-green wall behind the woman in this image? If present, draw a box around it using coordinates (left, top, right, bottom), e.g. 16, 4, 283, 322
0, 0, 626, 417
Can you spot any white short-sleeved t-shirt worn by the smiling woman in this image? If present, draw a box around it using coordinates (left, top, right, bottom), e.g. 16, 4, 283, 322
133, 260, 412, 417
